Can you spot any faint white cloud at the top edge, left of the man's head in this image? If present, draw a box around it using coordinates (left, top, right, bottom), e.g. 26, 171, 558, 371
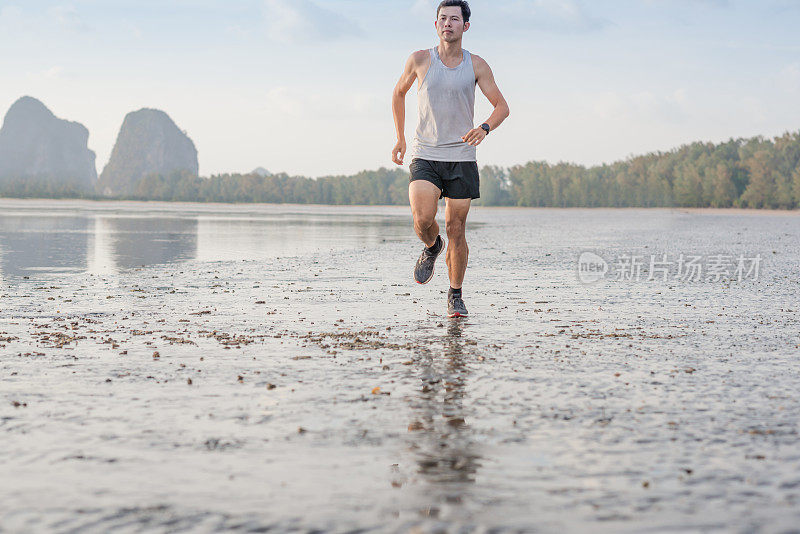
264, 0, 363, 43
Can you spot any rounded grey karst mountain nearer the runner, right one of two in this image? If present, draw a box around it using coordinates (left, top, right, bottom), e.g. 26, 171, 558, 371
98, 108, 198, 196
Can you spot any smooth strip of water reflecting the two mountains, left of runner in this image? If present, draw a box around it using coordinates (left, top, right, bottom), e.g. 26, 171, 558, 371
0, 201, 409, 280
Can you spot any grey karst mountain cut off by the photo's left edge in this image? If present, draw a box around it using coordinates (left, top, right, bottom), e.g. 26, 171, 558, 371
0, 96, 97, 190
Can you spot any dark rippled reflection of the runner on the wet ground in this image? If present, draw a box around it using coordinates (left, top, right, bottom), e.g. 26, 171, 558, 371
408, 319, 481, 515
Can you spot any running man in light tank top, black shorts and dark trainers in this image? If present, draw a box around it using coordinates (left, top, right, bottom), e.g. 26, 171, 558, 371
392, 0, 509, 317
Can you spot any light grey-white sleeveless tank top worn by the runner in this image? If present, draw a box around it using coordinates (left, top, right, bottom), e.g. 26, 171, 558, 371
413, 47, 476, 161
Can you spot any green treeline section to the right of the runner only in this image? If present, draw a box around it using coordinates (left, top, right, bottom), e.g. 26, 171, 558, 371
500, 132, 800, 209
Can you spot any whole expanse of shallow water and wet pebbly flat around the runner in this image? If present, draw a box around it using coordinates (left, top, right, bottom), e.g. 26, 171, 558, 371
0, 200, 800, 532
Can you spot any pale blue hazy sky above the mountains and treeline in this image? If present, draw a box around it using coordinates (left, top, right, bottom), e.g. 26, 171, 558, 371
0, 0, 800, 176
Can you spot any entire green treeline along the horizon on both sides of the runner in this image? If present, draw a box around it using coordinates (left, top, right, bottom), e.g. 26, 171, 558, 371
0, 132, 800, 209
